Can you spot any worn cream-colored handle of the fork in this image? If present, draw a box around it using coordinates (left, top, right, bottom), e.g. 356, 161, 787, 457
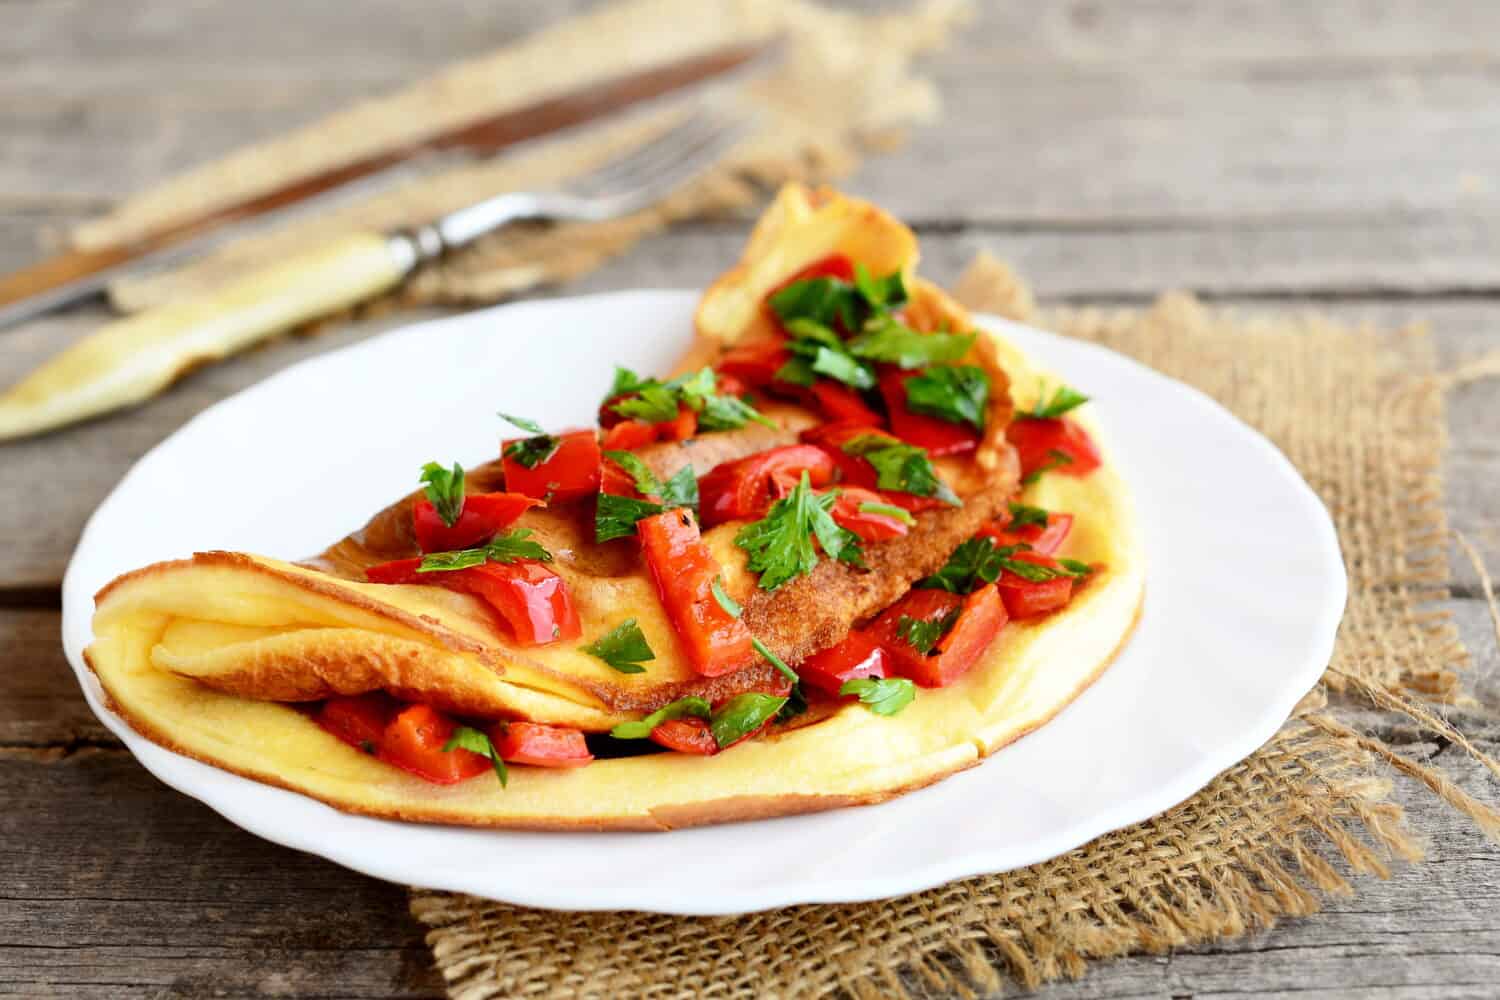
0, 232, 414, 441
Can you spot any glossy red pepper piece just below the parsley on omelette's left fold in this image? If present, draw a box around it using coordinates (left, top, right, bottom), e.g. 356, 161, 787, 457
365, 559, 584, 646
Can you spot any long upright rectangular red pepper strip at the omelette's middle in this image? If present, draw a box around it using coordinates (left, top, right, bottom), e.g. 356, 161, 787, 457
636, 510, 756, 678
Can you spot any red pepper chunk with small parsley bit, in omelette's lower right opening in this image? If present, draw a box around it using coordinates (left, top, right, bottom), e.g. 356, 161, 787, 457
873, 583, 1007, 688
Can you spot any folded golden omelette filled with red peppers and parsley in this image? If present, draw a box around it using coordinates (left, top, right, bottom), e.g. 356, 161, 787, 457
86, 184, 1145, 831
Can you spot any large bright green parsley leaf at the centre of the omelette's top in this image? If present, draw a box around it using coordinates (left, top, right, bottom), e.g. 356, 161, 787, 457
735, 471, 864, 591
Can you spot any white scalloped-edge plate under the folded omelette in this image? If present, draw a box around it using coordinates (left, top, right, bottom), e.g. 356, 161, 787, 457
63, 291, 1346, 915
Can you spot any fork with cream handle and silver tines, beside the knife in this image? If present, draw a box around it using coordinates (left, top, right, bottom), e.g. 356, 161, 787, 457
0, 106, 752, 441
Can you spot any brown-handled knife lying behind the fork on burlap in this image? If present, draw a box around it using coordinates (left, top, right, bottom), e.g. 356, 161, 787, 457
0, 42, 774, 328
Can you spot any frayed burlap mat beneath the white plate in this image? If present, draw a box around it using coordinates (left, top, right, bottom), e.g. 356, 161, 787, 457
411, 251, 1500, 1000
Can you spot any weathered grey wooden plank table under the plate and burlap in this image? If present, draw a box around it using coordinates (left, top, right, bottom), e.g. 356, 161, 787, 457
0, 0, 1500, 997
